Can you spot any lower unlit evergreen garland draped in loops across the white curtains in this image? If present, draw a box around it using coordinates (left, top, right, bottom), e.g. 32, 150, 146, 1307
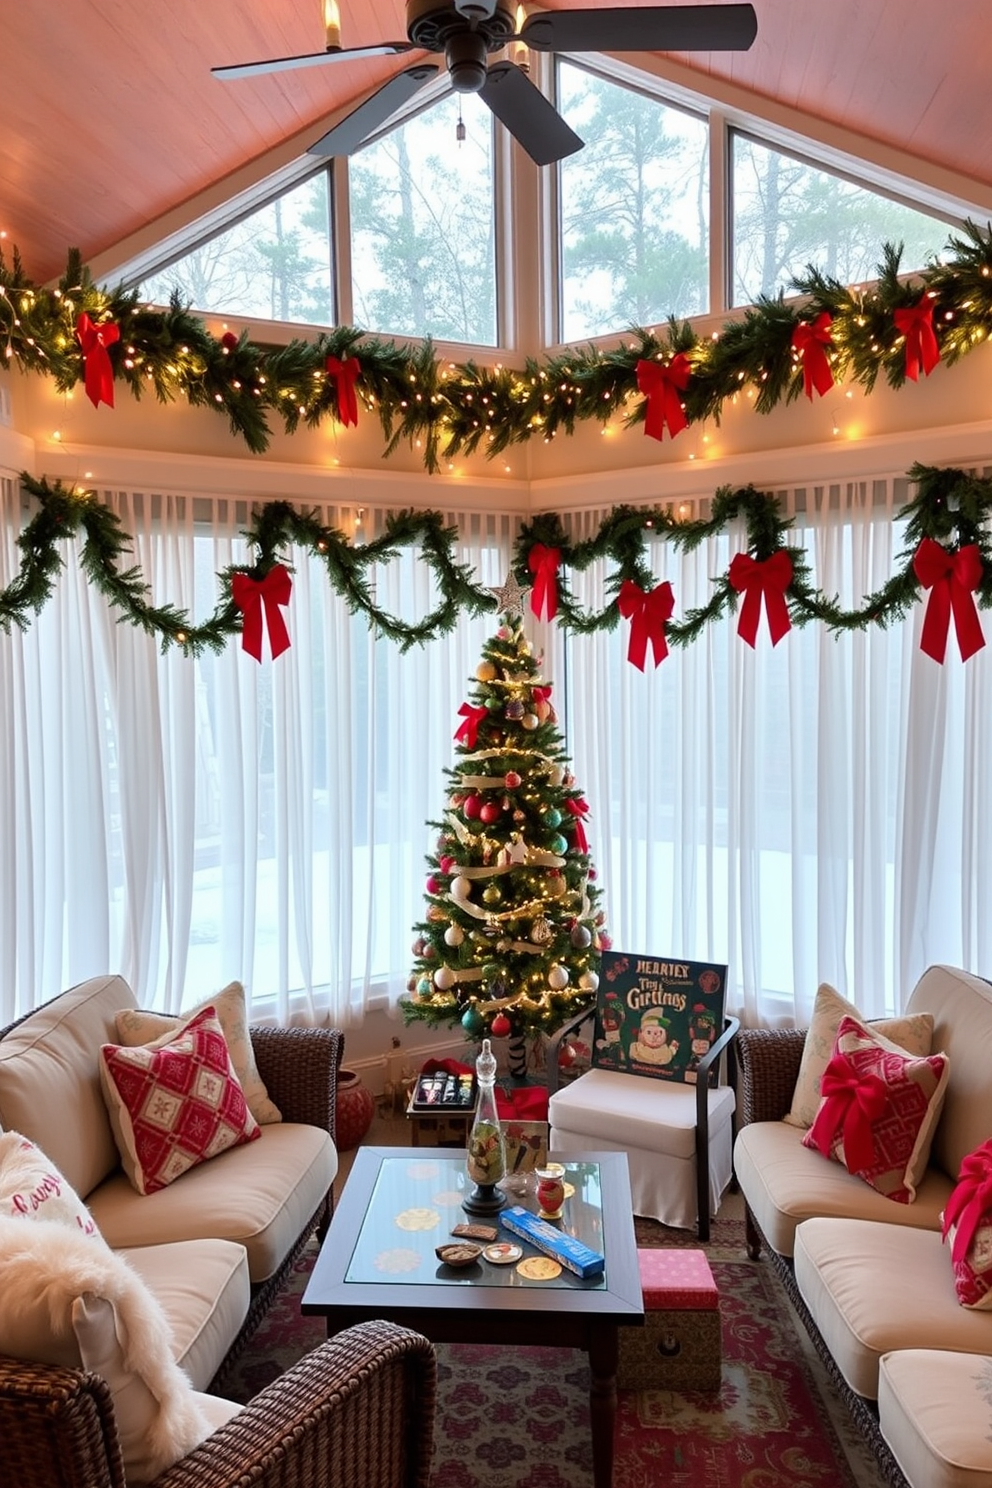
0, 464, 992, 656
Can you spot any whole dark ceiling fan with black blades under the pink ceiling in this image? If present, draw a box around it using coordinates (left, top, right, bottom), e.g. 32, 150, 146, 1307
211, 0, 757, 165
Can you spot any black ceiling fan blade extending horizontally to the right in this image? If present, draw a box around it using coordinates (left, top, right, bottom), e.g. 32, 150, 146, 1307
521, 4, 757, 52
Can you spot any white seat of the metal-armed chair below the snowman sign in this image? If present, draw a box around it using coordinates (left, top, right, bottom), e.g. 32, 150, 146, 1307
547, 1070, 735, 1159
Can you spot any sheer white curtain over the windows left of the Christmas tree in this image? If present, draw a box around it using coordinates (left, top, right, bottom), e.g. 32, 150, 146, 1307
0, 481, 515, 1027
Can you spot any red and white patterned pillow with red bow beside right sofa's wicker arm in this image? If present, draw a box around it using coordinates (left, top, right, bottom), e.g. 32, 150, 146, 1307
803, 1018, 947, 1204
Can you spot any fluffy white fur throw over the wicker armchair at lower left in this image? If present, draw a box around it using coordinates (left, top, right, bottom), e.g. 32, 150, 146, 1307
0, 1217, 211, 1484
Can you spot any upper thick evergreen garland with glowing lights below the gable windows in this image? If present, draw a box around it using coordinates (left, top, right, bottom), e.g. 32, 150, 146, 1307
0, 223, 992, 472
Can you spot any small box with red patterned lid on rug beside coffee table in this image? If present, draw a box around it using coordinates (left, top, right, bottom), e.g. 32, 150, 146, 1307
617, 1250, 720, 1390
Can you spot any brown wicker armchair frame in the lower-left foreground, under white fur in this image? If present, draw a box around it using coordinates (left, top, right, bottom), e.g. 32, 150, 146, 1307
0, 1323, 436, 1488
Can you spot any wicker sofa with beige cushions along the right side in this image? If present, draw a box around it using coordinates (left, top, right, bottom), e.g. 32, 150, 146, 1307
735, 966, 992, 1488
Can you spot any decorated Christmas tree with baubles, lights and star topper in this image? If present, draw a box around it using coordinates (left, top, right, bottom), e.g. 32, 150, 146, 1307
402, 580, 608, 1073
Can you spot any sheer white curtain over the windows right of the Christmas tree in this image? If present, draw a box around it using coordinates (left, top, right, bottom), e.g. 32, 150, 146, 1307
552, 476, 992, 1024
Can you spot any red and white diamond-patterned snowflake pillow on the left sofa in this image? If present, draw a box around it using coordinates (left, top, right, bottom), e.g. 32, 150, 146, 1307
100, 1007, 262, 1193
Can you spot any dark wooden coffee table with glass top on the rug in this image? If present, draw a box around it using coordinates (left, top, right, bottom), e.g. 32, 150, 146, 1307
300, 1147, 644, 1488
